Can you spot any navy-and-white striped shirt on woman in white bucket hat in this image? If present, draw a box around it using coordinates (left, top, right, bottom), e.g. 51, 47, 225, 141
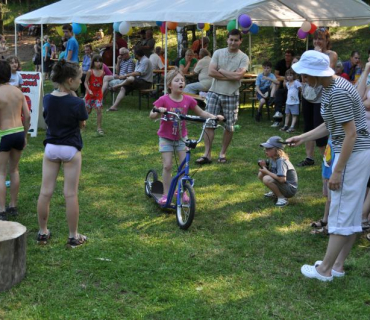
321, 77, 370, 153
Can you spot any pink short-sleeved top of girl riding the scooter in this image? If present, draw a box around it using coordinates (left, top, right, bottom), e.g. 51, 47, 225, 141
153, 94, 197, 140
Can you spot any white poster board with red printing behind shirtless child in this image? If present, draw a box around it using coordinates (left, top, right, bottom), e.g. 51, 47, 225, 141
20, 71, 46, 137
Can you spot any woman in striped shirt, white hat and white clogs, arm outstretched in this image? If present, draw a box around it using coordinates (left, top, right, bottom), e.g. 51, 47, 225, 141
287, 50, 370, 281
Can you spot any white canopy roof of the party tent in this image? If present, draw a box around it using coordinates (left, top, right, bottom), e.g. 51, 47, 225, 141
15, 0, 370, 27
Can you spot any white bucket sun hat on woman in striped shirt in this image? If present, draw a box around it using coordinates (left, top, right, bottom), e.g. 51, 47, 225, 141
292, 50, 334, 77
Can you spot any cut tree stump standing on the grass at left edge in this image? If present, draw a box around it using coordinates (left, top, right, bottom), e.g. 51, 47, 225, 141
0, 221, 27, 292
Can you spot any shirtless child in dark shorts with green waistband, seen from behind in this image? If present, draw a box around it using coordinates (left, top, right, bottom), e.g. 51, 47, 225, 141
0, 60, 31, 220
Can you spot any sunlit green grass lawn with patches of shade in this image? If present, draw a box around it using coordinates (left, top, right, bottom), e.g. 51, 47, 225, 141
0, 88, 370, 319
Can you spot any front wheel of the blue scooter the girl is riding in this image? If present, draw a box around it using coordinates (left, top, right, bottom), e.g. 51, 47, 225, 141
176, 183, 195, 230
